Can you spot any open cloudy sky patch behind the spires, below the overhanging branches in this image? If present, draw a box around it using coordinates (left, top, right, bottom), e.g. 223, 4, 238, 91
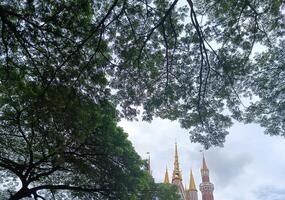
119, 119, 285, 200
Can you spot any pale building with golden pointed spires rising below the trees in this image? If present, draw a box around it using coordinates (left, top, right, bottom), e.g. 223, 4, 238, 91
160, 144, 214, 200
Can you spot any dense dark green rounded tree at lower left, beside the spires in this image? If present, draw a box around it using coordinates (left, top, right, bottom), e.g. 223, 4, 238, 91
0, 78, 154, 200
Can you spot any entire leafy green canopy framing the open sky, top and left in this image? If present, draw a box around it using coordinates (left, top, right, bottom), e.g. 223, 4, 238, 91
0, 0, 285, 199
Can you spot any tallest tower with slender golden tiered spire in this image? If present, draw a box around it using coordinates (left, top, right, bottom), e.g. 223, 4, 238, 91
172, 142, 186, 200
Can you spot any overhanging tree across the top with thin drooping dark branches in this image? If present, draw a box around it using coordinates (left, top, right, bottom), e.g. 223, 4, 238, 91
1, 0, 284, 148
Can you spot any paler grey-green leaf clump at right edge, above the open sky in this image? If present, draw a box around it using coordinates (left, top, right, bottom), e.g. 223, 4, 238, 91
245, 41, 285, 137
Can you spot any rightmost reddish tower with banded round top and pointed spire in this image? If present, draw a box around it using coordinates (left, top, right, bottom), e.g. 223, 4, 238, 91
200, 155, 214, 200
